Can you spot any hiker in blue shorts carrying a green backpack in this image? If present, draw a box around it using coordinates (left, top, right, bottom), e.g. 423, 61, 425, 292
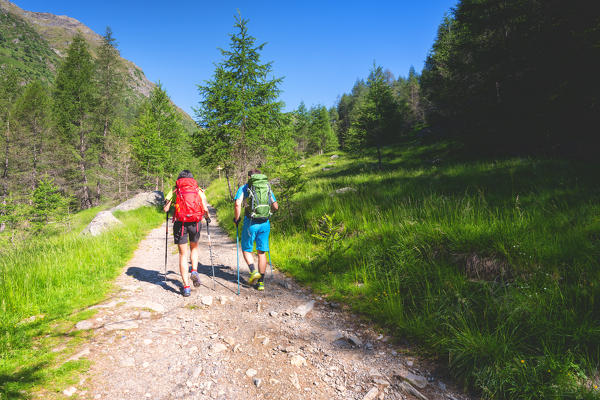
233, 169, 279, 290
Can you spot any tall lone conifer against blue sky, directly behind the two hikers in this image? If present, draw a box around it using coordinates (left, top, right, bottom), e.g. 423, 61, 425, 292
196, 16, 282, 189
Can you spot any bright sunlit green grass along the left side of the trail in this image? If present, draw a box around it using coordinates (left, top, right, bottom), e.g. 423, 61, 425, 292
0, 207, 164, 399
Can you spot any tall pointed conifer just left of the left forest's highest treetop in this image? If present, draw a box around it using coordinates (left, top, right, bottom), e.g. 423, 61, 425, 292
54, 34, 99, 209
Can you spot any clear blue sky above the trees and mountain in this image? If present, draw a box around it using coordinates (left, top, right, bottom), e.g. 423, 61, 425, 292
14, 0, 456, 116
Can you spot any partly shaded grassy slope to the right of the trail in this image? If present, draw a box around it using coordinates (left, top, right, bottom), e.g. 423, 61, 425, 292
207, 143, 600, 399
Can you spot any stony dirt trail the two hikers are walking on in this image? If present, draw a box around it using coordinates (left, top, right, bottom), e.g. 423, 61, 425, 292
66, 210, 466, 400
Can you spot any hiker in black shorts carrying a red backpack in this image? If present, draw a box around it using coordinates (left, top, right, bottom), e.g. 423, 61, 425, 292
163, 169, 210, 297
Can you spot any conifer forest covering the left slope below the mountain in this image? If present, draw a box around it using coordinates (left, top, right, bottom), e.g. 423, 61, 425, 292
0, 28, 202, 242
